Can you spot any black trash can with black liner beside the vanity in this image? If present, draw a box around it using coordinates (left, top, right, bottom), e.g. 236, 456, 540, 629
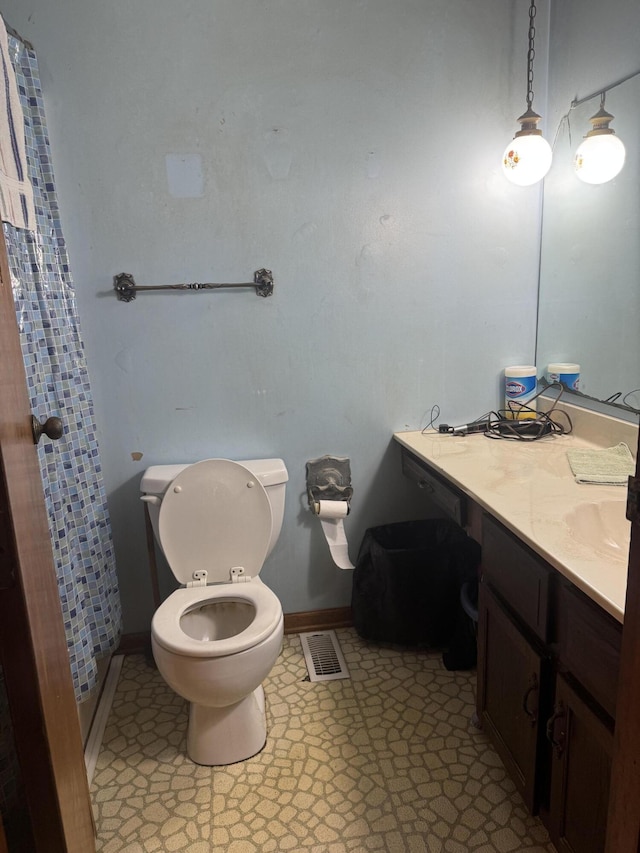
351, 518, 480, 669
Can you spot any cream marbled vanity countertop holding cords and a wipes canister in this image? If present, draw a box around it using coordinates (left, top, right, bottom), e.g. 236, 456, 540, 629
394, 410, 637, 622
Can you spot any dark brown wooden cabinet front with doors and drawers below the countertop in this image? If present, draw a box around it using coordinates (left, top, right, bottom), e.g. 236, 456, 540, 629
477, 515, 622, 853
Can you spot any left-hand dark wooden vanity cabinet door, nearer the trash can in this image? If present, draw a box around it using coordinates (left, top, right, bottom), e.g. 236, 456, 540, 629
478, 583, 547, 813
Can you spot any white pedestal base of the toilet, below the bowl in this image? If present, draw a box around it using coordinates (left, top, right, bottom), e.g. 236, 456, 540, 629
187, 685, 267, 767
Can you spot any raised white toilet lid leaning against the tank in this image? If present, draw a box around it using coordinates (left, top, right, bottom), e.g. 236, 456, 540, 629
158, 459, 271, 584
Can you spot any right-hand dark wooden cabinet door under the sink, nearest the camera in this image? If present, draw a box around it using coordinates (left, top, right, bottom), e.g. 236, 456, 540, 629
547, 675, 613, 853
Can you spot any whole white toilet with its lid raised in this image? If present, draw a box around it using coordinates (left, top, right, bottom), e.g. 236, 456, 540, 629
140, 459, 288, 765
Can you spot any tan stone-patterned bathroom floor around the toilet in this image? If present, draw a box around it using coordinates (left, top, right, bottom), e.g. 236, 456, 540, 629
92, 629, 554, 853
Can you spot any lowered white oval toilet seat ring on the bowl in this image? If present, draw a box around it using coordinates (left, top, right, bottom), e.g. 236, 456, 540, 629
151, 580, 282, 658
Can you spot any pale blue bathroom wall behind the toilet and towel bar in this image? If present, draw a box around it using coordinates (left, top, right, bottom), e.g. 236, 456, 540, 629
2, 0, 546, 631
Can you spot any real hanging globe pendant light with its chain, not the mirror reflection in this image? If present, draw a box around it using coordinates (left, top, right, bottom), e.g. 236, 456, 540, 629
502, 0, 552, 187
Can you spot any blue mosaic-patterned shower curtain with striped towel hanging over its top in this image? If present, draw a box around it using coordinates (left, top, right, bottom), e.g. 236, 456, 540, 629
0, 17, 121, 702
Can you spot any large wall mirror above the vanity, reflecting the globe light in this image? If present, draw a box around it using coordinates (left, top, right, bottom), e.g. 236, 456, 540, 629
536, 76, 640, 410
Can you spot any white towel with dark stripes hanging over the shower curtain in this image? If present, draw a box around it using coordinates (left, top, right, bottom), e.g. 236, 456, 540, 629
0, 15, 36, 231
